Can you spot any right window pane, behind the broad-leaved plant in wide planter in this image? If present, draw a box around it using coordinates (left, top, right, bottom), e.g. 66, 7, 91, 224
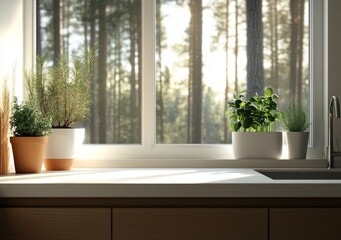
156, 0, 310, 143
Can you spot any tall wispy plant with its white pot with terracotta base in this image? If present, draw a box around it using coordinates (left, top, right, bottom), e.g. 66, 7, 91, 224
26, 49, 94, 170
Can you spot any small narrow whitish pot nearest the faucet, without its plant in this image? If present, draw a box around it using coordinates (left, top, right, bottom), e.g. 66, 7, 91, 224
285, 132, 309, 159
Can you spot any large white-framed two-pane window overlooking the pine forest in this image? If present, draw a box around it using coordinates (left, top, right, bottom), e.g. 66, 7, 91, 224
32, 0, 323, 160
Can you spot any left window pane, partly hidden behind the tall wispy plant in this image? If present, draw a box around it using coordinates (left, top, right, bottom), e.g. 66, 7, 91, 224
37, 0, 142, 144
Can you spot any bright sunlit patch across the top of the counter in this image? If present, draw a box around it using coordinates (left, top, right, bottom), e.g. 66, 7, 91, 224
0, 169, 256, 184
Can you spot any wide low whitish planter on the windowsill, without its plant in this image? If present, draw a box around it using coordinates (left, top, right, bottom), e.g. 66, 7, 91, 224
232, 132, 283, 159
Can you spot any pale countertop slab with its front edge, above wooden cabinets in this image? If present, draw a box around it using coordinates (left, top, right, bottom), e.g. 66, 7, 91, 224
0, 168, 341, 198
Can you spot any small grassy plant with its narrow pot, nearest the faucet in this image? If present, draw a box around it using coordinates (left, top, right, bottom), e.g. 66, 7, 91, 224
280, 102, 310, 159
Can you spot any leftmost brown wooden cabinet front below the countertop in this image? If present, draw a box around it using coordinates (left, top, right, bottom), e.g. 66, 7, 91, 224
0, 208, 111, 240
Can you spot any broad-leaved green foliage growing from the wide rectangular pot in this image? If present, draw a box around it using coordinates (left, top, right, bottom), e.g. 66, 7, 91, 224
225, 88, 280, 132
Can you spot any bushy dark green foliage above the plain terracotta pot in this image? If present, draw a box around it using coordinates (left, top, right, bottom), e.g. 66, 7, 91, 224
10, 98, 52, 137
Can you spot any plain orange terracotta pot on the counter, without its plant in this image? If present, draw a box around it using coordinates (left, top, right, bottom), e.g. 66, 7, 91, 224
10, 136, 48, 173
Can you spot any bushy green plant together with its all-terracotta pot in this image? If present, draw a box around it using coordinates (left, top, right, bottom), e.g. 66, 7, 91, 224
10, 98, 52, 173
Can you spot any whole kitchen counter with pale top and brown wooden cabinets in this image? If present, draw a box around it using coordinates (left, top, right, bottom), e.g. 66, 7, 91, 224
0, 168, 341, 240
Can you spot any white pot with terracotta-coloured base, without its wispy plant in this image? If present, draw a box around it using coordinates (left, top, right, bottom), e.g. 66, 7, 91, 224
44, 128, 85, 171
